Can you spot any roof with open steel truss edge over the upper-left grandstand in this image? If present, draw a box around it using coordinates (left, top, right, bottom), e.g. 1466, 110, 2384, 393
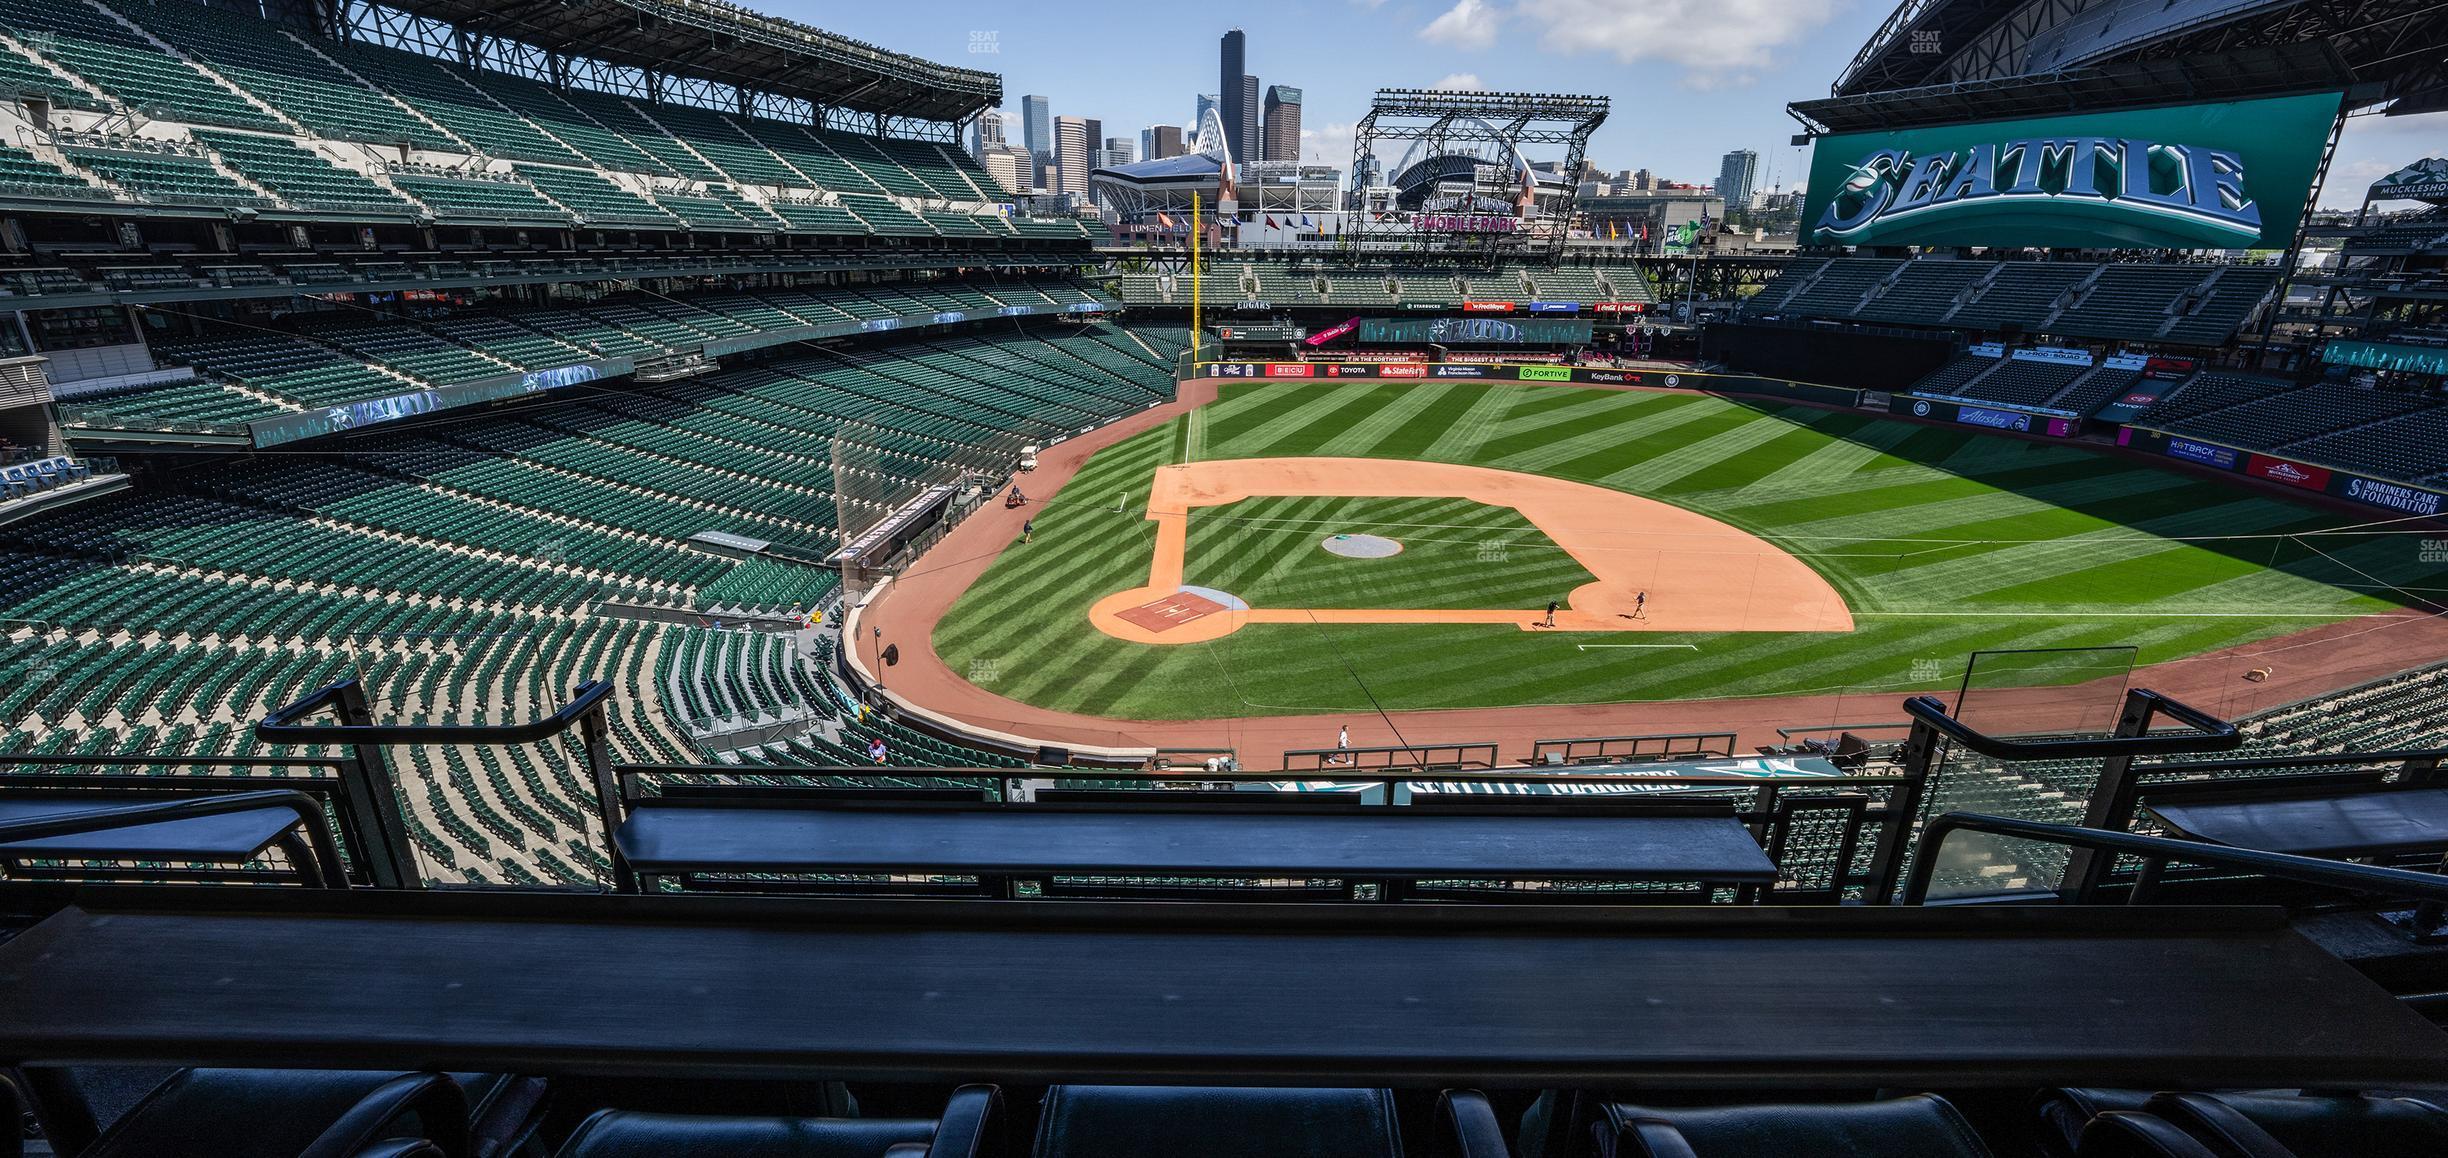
340, 0, 1004, 129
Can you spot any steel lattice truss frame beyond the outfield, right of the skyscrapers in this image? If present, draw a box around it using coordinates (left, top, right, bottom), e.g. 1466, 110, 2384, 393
1351, 88, 1611, 260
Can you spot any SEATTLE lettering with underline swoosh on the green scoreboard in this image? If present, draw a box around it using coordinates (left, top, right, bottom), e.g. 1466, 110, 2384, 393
1812, 137, 2262, 250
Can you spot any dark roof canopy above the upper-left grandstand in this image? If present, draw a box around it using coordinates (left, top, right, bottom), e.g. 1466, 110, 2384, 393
384, 0, 1004, 120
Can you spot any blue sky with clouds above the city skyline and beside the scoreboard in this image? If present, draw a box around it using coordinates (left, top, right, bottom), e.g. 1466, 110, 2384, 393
783, 0, 2448, 206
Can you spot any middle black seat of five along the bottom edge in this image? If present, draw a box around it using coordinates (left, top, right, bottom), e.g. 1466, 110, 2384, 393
1036, 1085, 1403, 1158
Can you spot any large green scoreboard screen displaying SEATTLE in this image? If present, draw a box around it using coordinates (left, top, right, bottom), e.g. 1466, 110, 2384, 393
1802, 93, 2338, 250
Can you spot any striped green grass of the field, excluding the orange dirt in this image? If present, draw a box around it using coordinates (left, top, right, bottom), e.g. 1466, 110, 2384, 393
935, 382, 2448, 720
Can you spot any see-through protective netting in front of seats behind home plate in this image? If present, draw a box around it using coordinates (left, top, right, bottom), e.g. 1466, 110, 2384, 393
832, 421, 1028, 605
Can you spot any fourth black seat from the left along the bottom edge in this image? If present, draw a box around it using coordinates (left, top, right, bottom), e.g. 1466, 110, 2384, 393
1594, 1094, 1990, 1158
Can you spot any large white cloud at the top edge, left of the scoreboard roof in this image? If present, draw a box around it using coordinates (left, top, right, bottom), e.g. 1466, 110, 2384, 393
1513, 0, 1841, 88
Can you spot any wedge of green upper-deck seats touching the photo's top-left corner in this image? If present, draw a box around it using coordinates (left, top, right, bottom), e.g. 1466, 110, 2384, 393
0, 0, 284, 130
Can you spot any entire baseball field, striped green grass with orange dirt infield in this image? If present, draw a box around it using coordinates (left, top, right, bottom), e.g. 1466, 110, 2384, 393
933, 382, 2448, 720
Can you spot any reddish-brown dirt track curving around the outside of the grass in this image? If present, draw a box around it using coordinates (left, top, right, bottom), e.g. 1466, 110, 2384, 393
852, 379, 2448, 769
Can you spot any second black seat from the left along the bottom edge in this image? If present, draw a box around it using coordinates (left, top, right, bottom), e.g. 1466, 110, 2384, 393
561, 1085, 999, 1158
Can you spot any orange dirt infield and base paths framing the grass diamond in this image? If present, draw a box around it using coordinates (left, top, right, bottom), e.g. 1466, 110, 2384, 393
1087, 458, 1853, 644
